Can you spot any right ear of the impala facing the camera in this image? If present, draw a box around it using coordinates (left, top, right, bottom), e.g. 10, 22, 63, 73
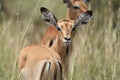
73, 11, 92, 28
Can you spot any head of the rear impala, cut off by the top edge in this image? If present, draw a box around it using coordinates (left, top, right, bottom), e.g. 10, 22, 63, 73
63, 0, 89, 16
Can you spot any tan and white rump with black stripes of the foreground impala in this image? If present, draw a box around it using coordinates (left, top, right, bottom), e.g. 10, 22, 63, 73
19, 45, 62, 80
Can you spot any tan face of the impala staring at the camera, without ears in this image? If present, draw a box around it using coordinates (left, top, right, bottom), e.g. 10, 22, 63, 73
58, 20, 74, 44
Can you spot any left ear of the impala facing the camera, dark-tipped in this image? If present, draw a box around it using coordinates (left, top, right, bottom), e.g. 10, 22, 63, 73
40, 7, 57, 27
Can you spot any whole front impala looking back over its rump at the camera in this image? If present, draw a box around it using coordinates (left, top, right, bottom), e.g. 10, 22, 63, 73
18, 7, 92, 80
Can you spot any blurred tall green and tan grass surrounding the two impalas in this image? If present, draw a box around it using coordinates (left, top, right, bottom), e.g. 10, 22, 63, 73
0, 0, 120, 80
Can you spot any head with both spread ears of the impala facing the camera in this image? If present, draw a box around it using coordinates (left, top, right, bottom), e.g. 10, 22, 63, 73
40, 7, 92, 44
